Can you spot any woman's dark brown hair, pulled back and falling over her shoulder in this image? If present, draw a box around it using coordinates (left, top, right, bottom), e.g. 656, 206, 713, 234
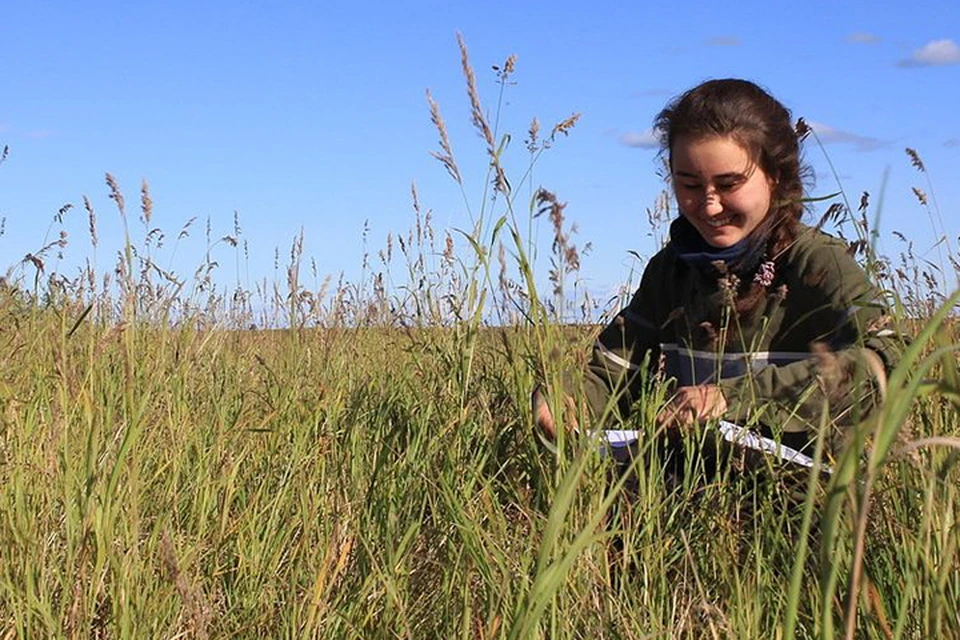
654, 78, 810, 312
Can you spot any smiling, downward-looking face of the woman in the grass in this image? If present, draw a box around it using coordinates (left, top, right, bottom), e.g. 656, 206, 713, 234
670, 136, 773, 249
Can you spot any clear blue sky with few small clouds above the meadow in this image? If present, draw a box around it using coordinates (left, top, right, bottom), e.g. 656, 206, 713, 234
0, 0, 960, 304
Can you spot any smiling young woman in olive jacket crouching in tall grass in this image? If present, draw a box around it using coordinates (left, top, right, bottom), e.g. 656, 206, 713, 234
534, 79, 899, 460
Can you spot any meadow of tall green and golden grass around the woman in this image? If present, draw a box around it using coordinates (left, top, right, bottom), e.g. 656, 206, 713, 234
0, 36, 960, 639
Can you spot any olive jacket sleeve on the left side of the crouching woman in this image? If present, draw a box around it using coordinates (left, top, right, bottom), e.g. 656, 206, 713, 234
565, 254, 664, 421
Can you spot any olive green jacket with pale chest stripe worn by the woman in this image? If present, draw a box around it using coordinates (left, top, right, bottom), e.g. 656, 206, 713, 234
584, 225, 901, 433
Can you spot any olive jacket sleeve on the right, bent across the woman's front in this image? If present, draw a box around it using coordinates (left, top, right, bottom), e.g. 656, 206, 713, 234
719, 241, 903, 432
